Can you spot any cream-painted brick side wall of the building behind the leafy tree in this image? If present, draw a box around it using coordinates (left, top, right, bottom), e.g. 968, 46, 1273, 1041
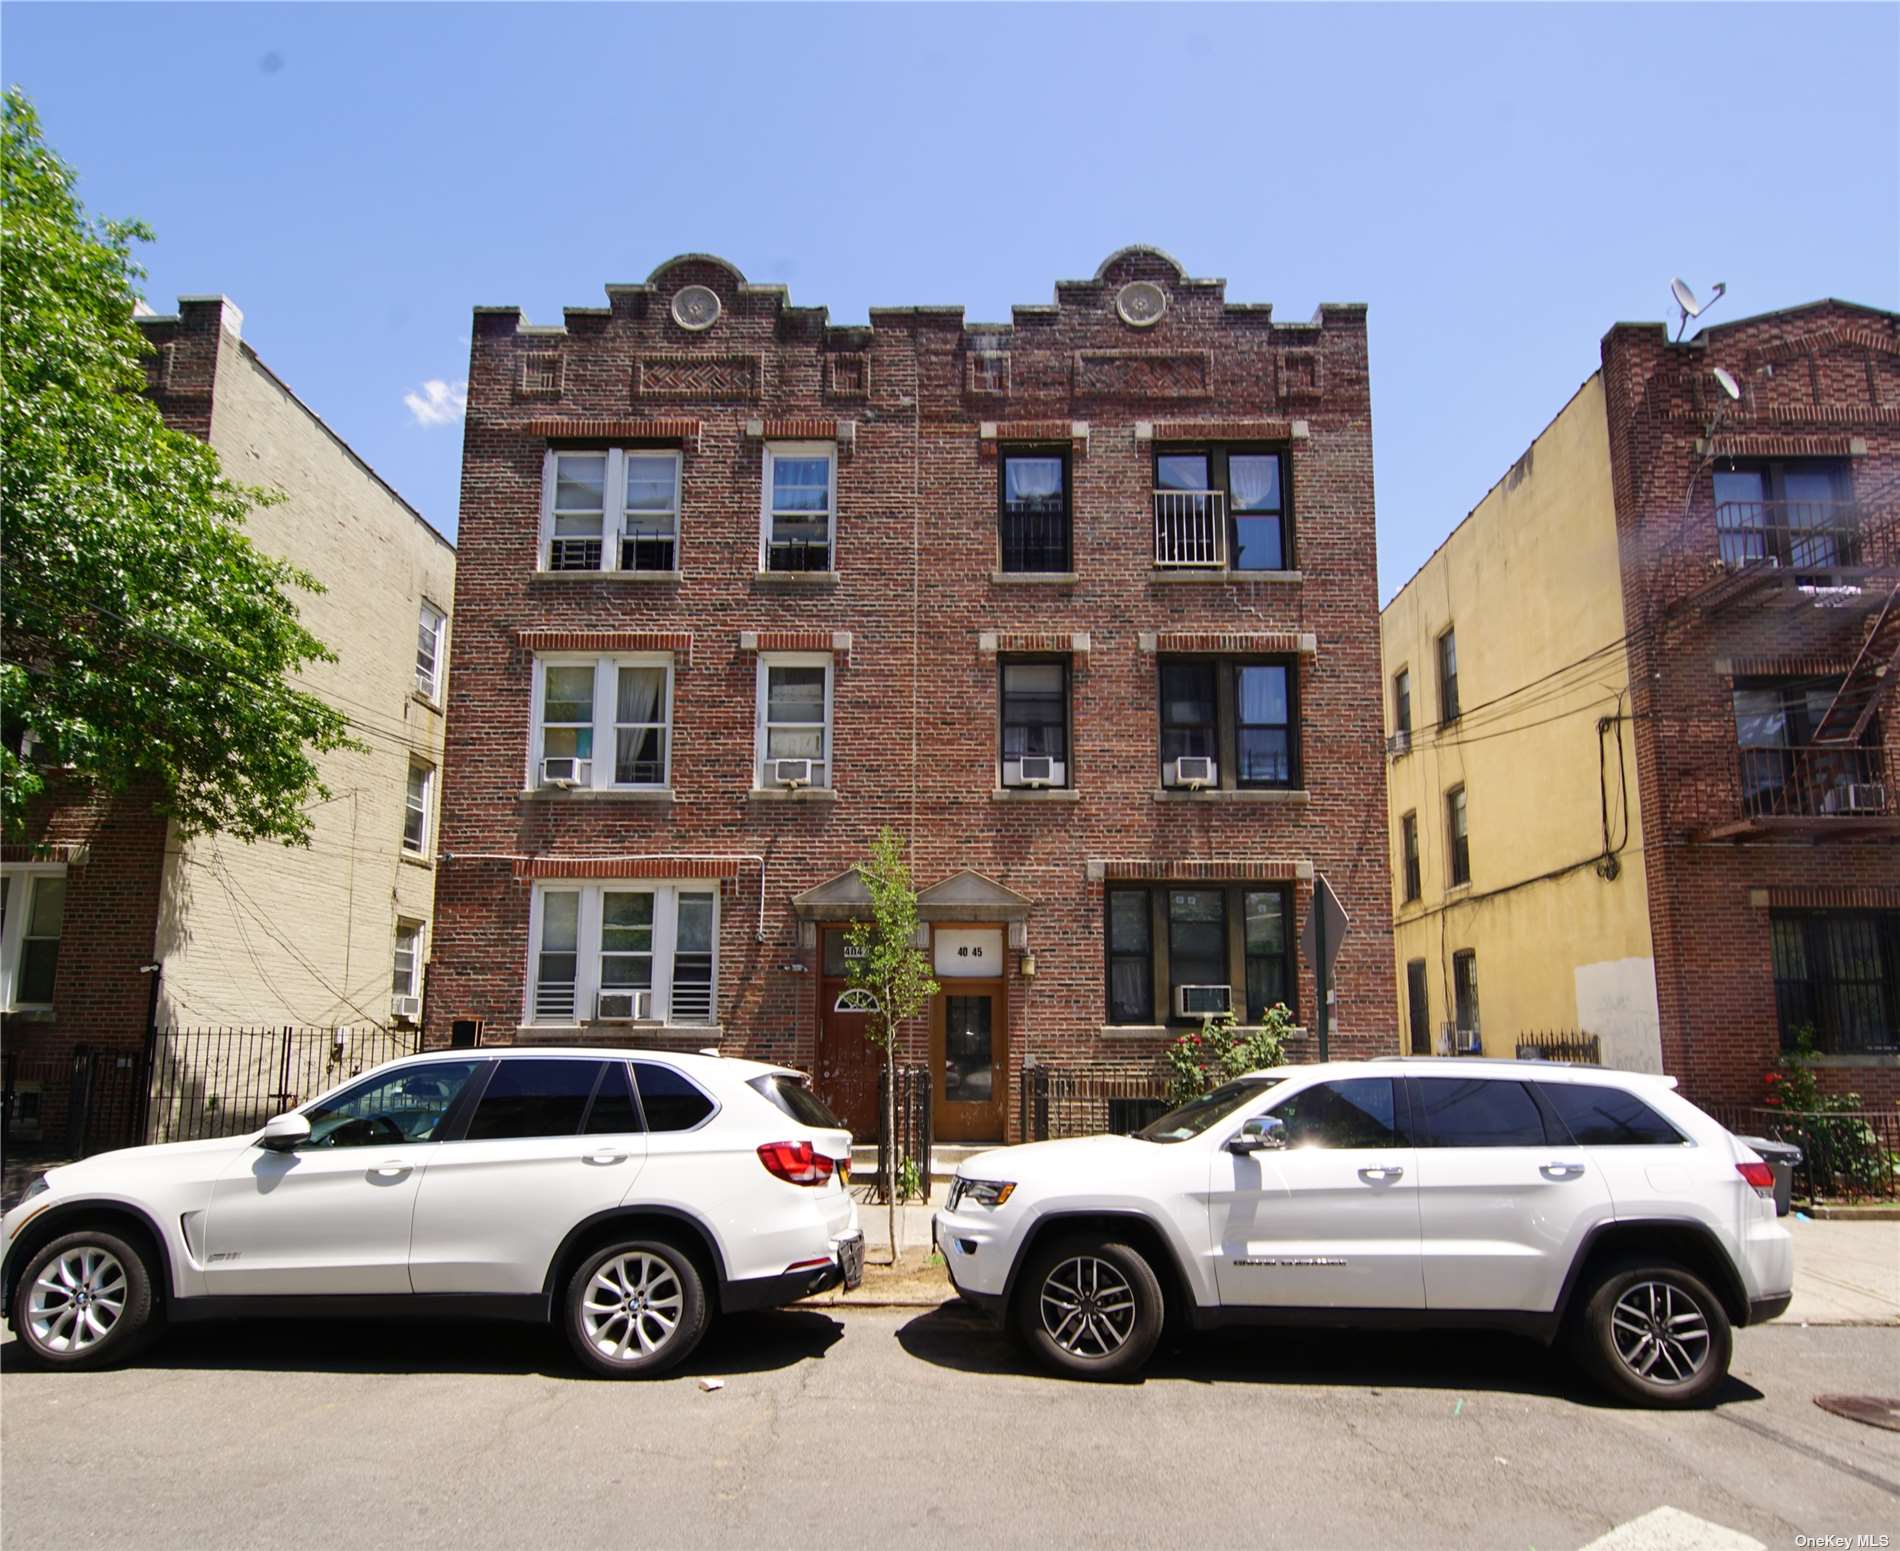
141, 297, 456, 1028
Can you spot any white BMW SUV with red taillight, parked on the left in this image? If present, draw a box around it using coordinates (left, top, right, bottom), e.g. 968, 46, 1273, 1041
0, 1049, 865, 1376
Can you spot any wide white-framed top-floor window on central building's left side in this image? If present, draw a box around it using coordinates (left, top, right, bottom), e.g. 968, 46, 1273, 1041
542, 447, 680, 572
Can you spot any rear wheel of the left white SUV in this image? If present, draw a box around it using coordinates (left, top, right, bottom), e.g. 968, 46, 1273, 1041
562, 1239, 707, 1378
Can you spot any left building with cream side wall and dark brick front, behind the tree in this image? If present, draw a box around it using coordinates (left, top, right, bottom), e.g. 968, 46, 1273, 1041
0, 297, 456, 1146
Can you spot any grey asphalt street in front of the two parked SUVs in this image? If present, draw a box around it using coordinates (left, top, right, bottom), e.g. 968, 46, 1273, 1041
0, 1306, 1900, 1551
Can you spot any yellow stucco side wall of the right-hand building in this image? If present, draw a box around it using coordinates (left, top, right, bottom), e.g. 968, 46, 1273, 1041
1381, 376, 1661, 1070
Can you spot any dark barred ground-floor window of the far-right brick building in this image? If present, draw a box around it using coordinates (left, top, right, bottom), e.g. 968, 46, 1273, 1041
1769, 910, 1900, 1055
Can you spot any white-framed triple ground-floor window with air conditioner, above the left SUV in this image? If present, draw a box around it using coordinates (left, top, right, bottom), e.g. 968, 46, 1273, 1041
528, 880, 718, 1024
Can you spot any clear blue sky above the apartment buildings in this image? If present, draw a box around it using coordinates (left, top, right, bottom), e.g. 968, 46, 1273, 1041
0, 4, 1900, 597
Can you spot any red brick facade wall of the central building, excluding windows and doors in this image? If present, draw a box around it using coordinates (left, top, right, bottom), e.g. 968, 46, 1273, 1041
428, 249, 1393, 1125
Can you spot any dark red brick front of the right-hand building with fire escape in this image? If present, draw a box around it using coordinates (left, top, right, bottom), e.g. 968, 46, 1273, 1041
1604, 302, 1900, 1104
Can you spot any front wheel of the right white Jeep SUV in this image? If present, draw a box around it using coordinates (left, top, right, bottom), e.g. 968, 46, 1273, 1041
1015, 1237, 1167, 1378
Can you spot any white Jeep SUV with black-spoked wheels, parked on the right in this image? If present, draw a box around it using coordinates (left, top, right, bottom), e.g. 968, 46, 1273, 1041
935, 1059, 1794, 1407
